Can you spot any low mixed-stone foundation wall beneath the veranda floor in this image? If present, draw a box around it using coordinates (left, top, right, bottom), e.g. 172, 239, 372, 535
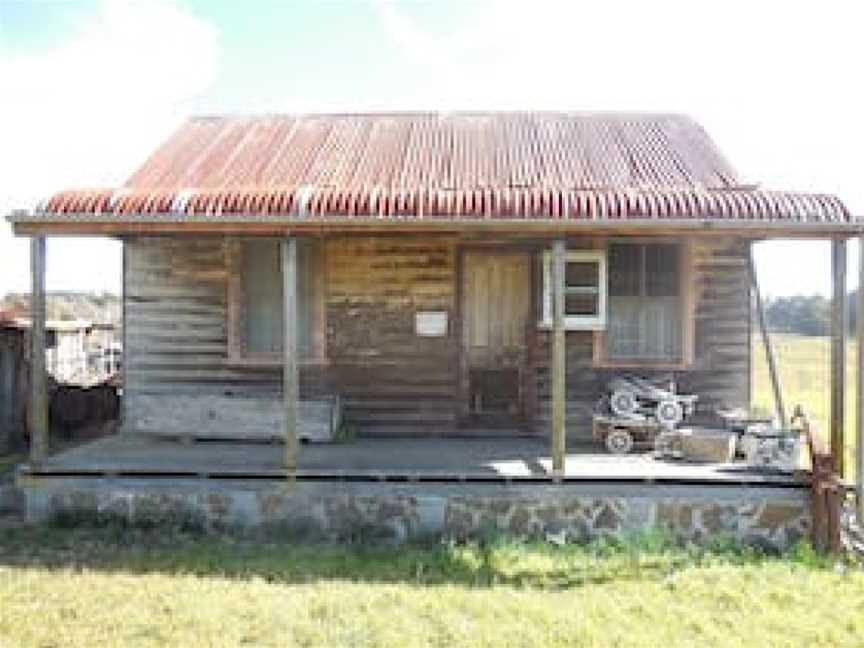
20, 477, 810, 550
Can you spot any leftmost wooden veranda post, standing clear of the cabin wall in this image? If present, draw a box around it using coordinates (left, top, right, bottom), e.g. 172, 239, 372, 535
29, 236, 48, 463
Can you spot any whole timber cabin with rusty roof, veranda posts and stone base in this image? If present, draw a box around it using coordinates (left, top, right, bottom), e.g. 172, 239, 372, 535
10, 113, 864, 548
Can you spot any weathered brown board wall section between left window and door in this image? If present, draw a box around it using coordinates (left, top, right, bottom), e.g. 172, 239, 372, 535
325, 237, 457, 434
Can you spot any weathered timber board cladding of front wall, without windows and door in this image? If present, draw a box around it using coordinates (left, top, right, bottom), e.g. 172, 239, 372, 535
124, 236, 750, 440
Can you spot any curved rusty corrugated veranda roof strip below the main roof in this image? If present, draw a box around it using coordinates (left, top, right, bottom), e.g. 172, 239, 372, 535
44, 187, 851, 223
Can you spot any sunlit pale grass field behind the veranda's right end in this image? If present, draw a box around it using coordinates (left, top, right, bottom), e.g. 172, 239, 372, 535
752, 333, 858, 479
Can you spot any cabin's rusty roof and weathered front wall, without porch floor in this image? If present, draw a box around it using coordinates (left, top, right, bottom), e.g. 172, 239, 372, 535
5, 113, 860, 466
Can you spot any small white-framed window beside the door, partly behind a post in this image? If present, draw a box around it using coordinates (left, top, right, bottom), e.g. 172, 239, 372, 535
542, 250, 606, 330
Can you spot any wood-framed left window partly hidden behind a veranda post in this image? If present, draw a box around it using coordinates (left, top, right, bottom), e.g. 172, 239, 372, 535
229, 239, 323, 363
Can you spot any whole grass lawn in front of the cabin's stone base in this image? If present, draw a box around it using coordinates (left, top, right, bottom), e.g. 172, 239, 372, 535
0, 528, 864, 648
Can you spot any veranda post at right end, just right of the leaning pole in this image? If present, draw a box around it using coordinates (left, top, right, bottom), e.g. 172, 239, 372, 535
831, 238, 847, 478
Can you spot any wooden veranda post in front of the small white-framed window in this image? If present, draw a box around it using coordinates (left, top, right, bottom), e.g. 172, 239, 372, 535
551, 239, 567, 477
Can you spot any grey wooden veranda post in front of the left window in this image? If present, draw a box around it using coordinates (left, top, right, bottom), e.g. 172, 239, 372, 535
281, 236, 300, 474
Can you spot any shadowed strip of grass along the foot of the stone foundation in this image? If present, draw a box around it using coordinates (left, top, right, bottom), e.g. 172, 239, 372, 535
0, 524, 792, 589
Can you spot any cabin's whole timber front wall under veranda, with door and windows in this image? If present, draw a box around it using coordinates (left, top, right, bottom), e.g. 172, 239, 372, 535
125, 215, 751, 440
